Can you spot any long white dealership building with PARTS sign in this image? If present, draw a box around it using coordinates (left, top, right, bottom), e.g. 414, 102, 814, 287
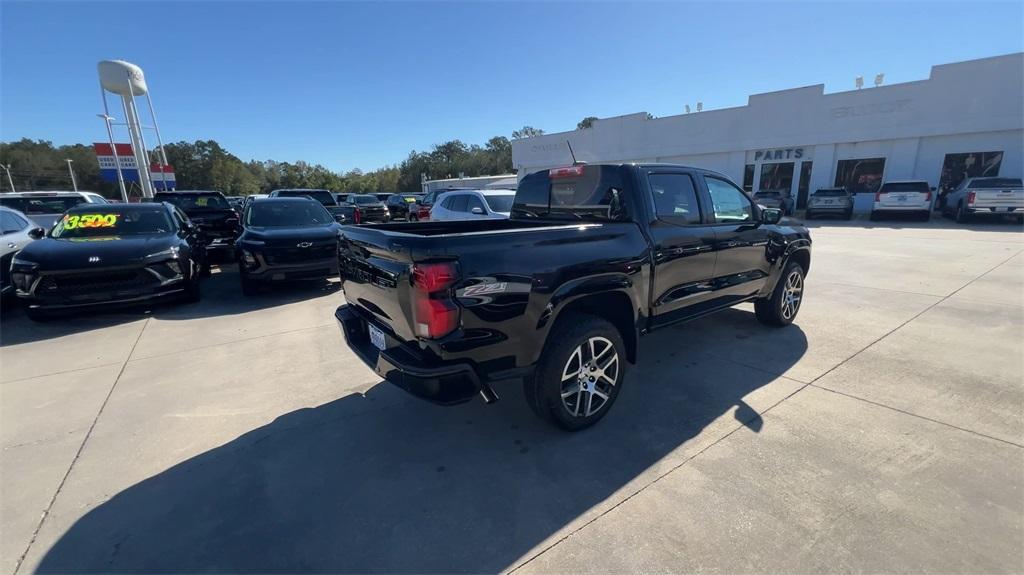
512, 53, 1024, 211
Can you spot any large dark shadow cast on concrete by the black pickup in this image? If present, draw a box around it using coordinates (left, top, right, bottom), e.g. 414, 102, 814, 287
39, 309, 807, 573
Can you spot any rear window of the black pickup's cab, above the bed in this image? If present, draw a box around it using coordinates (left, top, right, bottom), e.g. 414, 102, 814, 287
512, 166, 629, 221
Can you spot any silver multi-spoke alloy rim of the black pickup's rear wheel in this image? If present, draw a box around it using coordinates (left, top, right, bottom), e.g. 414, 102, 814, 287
561, 336, 621, 417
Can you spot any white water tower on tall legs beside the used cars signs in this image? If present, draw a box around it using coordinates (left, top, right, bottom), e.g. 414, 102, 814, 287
96, 60, 168, 197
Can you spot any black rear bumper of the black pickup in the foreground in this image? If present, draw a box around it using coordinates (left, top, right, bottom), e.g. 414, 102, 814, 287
334, 305, 497, 405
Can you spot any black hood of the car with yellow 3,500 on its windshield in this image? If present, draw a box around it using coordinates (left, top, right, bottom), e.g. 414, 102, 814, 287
17, 233, 180, 271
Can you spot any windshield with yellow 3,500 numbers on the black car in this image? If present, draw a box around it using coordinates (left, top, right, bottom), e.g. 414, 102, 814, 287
50, 205, 174, 238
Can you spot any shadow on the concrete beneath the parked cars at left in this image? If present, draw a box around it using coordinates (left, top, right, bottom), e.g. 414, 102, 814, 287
0, 264, 341, 347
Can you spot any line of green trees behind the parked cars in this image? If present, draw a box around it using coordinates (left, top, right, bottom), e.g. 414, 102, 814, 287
0, 126, 544, 198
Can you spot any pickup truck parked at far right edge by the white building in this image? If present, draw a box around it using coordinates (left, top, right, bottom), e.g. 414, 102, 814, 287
942, 177, 1024, 223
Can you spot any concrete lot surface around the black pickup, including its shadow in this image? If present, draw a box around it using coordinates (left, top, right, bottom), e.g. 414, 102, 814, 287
0, 219, 1024, 573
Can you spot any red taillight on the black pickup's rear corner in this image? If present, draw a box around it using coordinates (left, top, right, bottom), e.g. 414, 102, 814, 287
413, 262, 459, 339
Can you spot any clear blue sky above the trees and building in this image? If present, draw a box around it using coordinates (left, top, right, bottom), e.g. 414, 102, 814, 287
0, 1, 1024, 170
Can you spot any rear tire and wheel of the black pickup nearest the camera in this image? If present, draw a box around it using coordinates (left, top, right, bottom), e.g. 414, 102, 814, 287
523, 314, 627, 431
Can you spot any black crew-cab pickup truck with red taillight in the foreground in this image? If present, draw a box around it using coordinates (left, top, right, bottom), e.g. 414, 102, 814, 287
335, 164, 811, 430
